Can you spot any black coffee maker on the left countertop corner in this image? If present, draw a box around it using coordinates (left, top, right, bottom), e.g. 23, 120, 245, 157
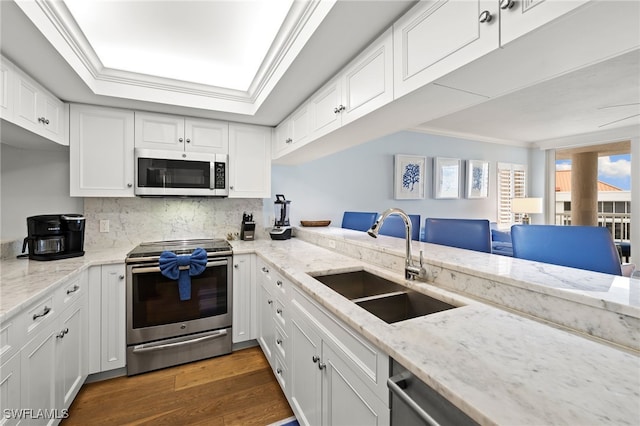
22, 214, 85, 260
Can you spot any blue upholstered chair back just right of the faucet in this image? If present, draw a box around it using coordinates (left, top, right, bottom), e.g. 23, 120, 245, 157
424, 217, 491, 253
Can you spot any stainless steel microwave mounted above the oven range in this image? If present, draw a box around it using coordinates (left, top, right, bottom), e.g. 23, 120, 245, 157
135, 148, 229, 197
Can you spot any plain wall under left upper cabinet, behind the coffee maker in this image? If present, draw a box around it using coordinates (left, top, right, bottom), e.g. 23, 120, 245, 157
0, 144, 84, 241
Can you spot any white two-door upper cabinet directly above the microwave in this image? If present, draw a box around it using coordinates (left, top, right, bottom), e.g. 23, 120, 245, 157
135, 111, 229, 154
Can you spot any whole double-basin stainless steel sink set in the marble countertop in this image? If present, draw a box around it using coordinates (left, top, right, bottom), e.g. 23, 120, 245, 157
314, 270, 456, 324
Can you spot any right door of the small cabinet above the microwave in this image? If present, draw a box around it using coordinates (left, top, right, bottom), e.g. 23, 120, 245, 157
184, 118, 229, 154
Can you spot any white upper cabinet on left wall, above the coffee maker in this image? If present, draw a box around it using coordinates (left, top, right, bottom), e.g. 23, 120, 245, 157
0, 58, 69, 145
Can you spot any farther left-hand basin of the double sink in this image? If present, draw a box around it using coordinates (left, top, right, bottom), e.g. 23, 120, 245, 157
314, 271, 406, 300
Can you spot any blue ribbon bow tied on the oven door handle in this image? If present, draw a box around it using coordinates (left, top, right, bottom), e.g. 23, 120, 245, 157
160, 247, 207, 301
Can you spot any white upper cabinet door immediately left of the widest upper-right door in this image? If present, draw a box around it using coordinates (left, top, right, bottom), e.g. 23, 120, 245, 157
342, 28, 393, 125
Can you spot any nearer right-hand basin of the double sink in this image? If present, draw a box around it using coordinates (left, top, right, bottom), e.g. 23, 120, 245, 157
354, 290, 456, 324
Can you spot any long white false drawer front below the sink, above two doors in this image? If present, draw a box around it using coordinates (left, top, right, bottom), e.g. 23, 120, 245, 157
291, 288, 389, 400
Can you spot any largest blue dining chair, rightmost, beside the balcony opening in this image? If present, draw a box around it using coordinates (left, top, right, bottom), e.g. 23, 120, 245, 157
511, 225, 622, 275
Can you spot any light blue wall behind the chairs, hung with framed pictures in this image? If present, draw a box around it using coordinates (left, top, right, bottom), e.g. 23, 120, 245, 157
265, 131, 544, 235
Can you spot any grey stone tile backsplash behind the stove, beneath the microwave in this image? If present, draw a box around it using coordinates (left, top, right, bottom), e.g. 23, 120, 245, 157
84, 197, 269, 250
